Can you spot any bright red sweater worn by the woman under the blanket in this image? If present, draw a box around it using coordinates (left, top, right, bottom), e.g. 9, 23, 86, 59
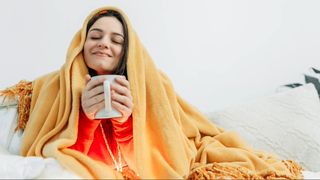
70, 109, 135, 170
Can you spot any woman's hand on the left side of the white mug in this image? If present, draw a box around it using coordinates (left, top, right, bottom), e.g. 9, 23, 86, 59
81, 74, 105, 120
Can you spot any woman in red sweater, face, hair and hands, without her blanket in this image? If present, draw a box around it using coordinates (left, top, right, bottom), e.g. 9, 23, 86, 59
71, 10, 136, 176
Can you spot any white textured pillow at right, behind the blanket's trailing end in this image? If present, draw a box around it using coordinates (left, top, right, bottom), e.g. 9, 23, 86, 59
208, 84, 320, 171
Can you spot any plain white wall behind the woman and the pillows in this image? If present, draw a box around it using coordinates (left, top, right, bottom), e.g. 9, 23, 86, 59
0, 0, 320, 112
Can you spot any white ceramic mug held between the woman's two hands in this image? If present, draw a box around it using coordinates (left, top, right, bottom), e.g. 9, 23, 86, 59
91, 75, 124, 119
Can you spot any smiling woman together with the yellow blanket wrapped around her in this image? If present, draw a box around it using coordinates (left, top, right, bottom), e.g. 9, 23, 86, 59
0, 7, 302, 179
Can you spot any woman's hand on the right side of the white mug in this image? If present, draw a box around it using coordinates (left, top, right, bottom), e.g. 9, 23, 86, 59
111, 77, 133, 123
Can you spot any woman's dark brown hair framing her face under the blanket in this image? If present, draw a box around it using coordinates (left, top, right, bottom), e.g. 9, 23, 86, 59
87, 10, 129, 77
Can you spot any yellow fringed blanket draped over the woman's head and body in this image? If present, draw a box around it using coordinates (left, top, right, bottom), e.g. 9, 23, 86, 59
0, 7, 302, 179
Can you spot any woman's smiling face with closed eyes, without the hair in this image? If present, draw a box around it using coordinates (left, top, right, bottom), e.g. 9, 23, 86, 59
83, 16, 124, 75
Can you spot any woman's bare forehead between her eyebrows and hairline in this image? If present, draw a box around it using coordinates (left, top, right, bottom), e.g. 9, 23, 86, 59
89, 16, 123, 34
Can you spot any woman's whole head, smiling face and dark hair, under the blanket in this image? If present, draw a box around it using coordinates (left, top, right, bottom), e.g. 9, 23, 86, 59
83, 11, 128, 75
